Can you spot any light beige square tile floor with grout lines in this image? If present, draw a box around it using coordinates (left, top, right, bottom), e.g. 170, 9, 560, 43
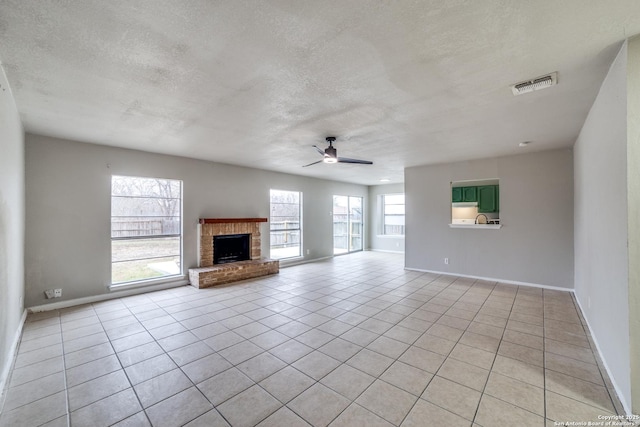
0, 252, 622, 427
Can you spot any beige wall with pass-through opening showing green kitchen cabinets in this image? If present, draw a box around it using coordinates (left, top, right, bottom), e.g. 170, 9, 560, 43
405, 150, 573, 289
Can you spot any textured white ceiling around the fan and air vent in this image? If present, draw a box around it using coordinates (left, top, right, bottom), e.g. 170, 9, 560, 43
0, 0, 640, 184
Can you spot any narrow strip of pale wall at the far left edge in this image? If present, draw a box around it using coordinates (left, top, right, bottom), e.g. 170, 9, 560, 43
0, 67, 25, 394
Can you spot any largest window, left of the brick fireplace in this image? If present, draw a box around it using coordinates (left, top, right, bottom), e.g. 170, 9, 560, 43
111, 176, 182, 284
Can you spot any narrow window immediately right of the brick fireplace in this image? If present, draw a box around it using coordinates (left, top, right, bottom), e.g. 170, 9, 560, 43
270, 190, 302, 259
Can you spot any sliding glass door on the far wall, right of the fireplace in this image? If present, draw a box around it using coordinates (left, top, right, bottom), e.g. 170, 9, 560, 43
333, 196, 364, 254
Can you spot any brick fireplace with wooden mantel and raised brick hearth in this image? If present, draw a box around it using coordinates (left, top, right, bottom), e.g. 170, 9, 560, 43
189, 218, 279, 288
